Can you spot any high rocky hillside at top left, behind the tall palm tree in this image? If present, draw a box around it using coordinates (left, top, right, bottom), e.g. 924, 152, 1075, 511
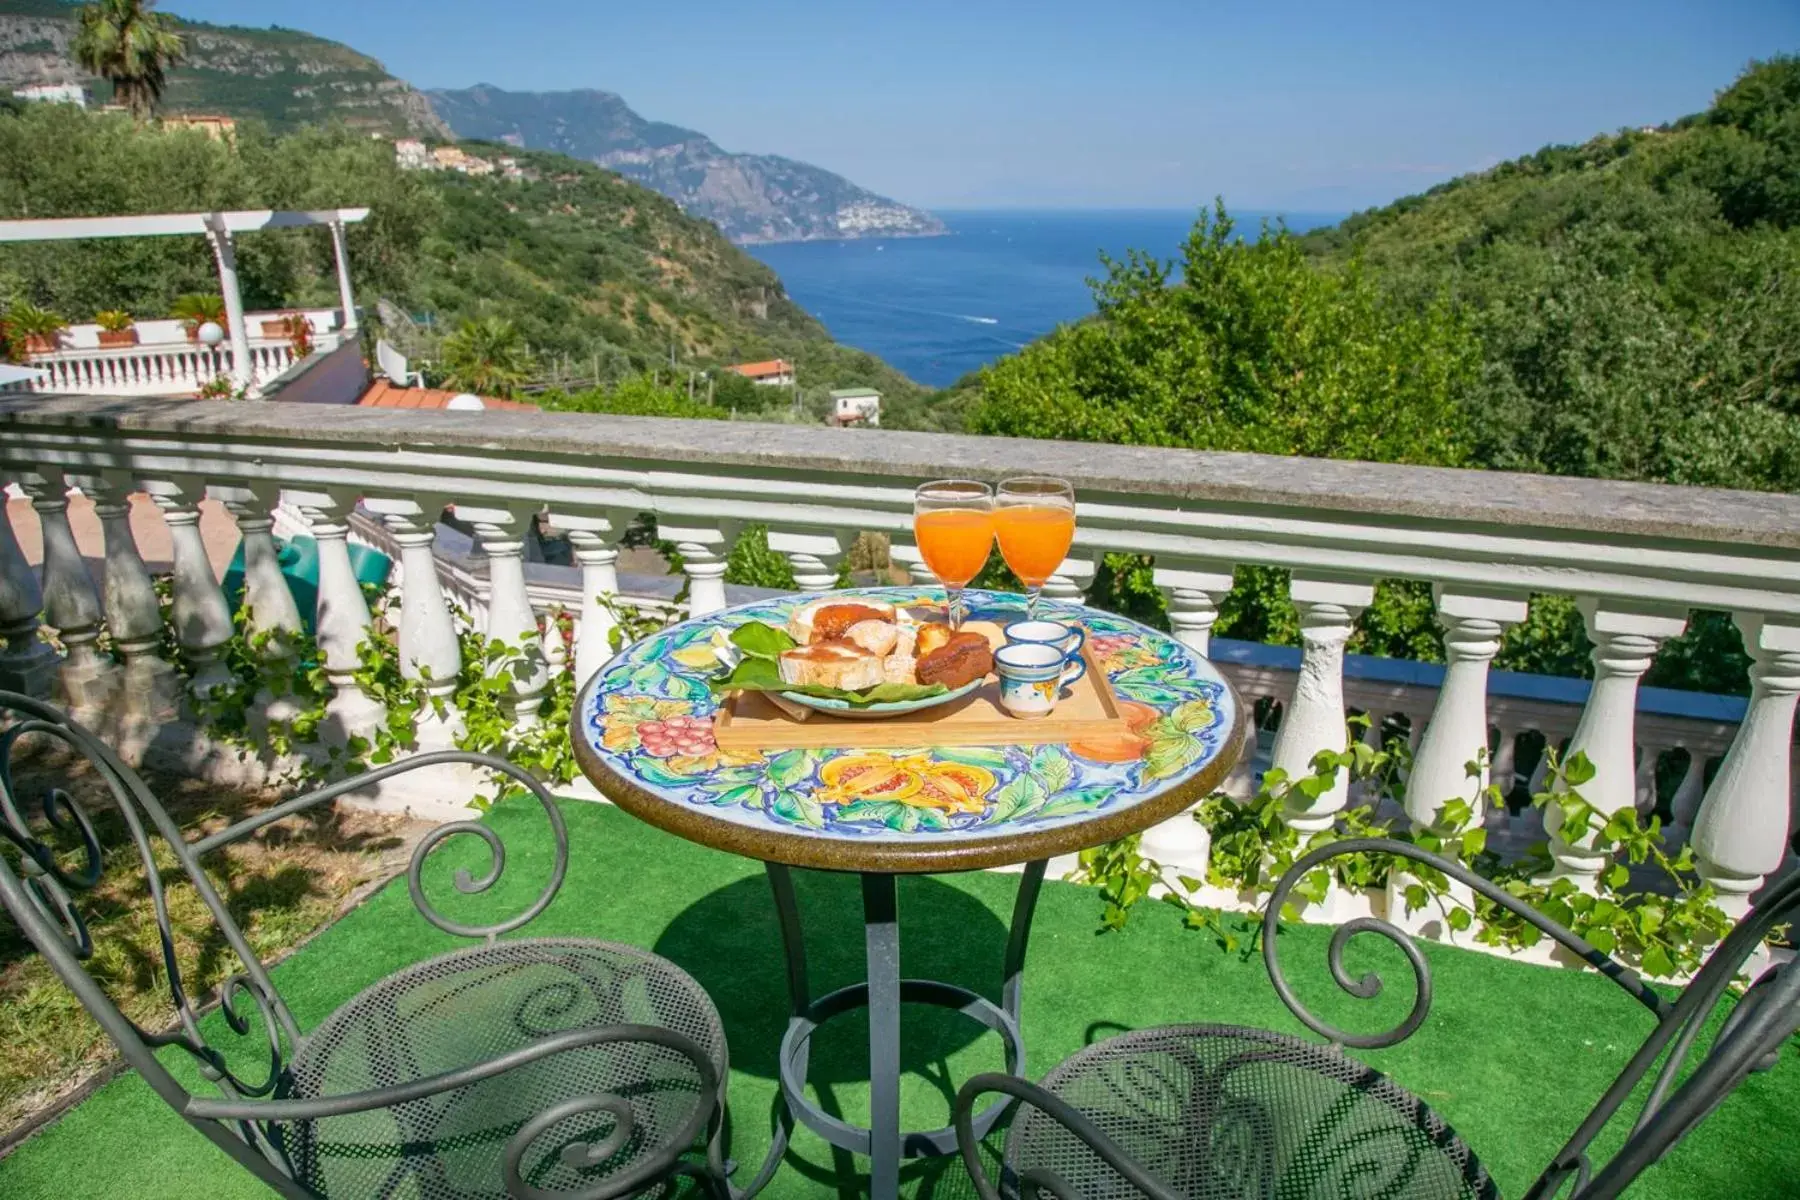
0, 0, 450, 137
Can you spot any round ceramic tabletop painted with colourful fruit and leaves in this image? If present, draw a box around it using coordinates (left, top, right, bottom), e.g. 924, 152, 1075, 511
572, 588, 1244, 871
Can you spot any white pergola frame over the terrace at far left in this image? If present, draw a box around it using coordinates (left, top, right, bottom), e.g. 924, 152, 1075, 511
0, 209, 369, 389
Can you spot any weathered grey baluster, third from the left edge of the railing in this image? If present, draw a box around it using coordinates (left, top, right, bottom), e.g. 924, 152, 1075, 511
83, 479, 180, 723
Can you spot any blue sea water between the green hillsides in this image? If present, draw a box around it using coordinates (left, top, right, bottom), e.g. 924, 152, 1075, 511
749, 209, 1343, 387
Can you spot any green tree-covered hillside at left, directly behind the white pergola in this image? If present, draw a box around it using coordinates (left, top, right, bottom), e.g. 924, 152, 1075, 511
0, 104, 923, 408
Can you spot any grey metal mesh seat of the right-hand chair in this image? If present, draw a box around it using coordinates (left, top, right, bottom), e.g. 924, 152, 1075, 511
1004, 1025, 1499, 1200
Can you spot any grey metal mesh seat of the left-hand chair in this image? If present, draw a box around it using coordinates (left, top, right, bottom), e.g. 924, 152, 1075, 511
284, 939, 727, 1200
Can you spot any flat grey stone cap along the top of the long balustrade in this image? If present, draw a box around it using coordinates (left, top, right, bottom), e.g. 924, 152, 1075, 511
0, 396, 1800, 549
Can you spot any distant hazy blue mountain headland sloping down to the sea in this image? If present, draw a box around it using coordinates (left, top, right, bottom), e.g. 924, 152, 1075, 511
428, 85, 945, 243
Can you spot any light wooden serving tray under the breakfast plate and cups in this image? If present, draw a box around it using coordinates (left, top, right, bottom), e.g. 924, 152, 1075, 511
713, 621, 1132, 754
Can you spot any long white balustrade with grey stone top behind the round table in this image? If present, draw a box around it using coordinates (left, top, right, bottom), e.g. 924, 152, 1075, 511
0, 398, 1800, 909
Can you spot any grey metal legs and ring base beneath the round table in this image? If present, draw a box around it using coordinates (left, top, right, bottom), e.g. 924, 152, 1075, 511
767, 860, 1048, 1200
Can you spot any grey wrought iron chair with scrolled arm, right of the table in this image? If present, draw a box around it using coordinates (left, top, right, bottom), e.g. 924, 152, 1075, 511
956, 838, 1800, 1200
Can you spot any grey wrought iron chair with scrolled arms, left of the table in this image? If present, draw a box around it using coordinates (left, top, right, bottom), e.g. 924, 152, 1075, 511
0, 693, 752, 1200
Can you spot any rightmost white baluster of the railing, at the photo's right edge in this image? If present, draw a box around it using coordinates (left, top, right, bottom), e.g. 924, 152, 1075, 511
1692, 613, 1800, 918
